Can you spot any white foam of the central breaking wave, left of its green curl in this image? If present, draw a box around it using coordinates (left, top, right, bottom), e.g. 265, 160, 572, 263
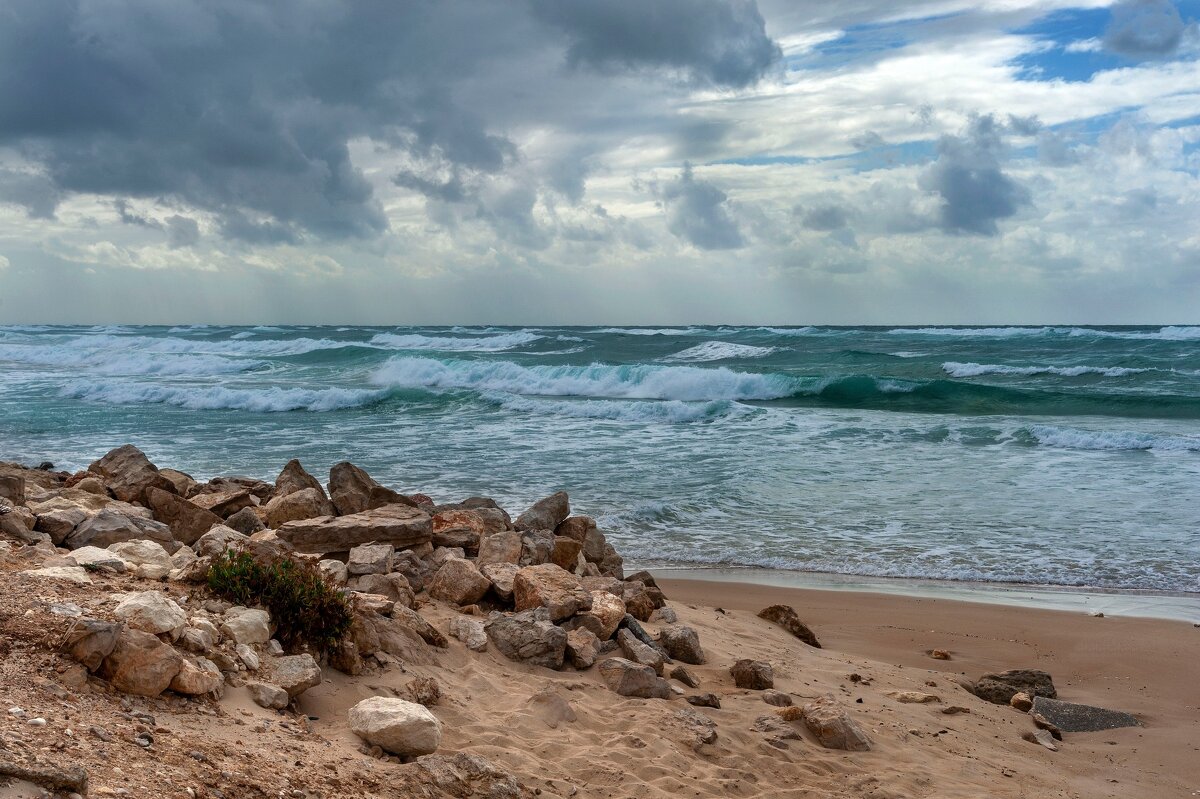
371, 356, 796, 402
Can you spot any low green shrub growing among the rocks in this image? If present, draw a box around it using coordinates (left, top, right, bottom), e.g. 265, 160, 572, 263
209, 549, 352, 653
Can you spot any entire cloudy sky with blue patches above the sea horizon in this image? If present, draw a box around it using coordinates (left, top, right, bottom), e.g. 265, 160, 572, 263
0, 0, 1200, 325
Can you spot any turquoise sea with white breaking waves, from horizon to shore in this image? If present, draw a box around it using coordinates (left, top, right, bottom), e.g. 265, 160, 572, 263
0, 326, 1200, 591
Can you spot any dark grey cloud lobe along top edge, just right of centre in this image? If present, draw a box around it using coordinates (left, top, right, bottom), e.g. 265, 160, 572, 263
533, 0, 781, 88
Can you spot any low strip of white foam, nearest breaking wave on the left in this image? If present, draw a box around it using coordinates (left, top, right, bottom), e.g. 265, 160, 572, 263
61, 380, 386, 413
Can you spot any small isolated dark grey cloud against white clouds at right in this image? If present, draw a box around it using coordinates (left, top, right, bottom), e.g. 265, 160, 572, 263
920, 114, 1030, 236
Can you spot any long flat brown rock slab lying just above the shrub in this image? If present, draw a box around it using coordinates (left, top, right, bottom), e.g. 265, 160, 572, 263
277, 505, 433, 554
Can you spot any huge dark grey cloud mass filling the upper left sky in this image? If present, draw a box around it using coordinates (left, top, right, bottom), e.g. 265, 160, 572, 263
0, 0, 778, 242
